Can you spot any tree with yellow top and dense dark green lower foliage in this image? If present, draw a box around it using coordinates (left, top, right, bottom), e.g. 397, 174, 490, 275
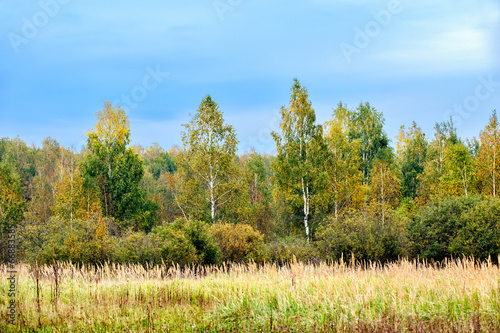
81, 103, 156, 230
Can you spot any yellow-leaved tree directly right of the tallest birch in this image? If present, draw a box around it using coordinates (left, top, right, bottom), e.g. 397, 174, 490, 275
324, 103, 362, 219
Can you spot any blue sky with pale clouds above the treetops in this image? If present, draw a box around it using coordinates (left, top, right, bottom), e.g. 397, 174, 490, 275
0, 0, 500, 153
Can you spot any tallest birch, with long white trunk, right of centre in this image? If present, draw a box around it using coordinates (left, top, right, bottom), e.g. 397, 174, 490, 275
272, 79, 323, 241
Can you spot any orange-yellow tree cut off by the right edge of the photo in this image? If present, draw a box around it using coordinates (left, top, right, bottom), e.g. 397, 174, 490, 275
476, 110, 500, 197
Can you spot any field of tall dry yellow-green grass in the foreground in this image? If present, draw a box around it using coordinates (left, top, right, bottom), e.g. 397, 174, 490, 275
0, 255, 500, 332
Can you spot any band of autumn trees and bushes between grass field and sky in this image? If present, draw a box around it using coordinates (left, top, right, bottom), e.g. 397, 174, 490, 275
0, 80, 500, 264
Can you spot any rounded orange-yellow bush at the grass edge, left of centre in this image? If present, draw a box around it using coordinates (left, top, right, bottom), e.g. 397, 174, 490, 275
210, 223, 265, 263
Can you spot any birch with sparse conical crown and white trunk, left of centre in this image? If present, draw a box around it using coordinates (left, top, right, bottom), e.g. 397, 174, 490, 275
178, 96, 239, 222
